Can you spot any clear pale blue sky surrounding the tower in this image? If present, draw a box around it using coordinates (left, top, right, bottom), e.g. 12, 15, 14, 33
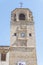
0, 0, 43, 65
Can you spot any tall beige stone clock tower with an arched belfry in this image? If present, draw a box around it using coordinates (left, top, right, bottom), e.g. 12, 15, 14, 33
9, 8, 37, 65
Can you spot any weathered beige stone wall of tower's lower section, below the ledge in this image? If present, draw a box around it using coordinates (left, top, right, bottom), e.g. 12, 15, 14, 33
10, 47, 36, 65
